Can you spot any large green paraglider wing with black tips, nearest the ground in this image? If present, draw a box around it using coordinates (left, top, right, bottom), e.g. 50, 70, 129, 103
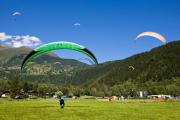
21, 42, 98, 70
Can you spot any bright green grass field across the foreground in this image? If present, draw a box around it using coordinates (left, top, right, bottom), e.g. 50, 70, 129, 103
0, 99, 180, 120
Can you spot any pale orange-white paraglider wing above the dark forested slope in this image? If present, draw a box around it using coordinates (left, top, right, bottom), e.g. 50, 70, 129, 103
136, 32, 167, 44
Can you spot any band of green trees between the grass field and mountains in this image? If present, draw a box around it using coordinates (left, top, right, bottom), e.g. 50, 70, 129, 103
0, 77, 180, 98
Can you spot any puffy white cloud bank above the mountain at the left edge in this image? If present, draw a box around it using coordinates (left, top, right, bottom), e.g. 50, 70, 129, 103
0, 33, 42, 47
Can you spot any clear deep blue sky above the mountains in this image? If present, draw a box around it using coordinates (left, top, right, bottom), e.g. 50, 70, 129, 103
0, 0, 180, 62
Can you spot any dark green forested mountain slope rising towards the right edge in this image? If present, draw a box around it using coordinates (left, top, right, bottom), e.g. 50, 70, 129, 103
70, 41, 180, 86
